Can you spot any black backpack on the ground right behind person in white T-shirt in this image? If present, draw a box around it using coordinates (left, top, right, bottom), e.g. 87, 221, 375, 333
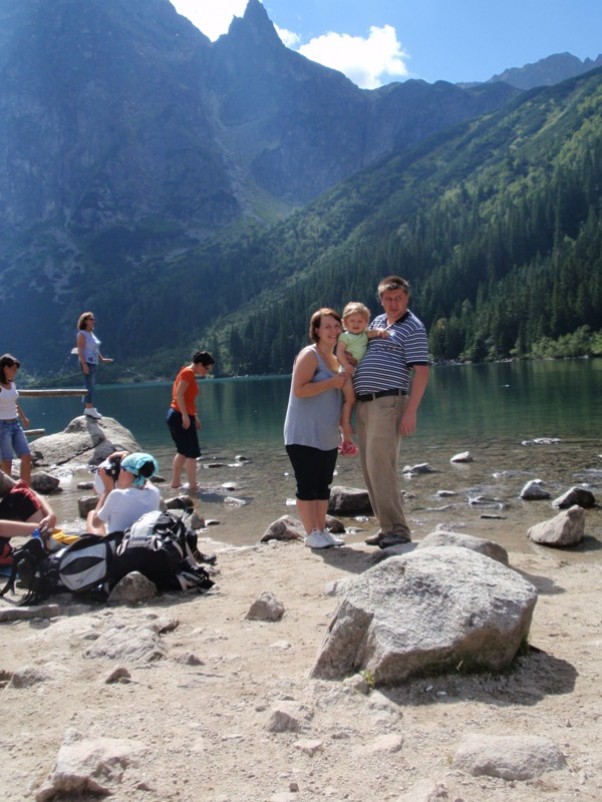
107, 510, 215, 592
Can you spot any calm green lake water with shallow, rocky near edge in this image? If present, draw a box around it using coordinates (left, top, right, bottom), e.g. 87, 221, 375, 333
23, 360, 602, 557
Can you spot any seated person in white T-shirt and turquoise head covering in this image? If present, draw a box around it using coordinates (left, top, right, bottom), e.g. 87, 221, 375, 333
86, 452, 161, 535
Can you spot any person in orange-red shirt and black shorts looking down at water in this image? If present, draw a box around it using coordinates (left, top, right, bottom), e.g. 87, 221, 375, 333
167, 351, 215, 493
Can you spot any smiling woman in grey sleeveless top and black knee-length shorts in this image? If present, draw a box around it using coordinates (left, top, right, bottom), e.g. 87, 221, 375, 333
284, 308, 351, 549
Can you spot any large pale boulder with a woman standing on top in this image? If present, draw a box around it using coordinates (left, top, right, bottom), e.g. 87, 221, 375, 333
31, 415, 141, 465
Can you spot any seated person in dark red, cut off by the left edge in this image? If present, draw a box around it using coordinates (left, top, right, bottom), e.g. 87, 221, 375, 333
0, 470, 56, 563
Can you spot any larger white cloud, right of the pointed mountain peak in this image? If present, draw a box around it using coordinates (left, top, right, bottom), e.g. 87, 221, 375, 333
299, 25, 409, 89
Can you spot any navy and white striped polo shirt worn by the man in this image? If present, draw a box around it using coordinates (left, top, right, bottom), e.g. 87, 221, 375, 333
353, 310, 430, 395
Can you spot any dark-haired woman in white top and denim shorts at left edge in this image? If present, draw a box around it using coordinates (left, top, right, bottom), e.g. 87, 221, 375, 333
0, 354, 31, 484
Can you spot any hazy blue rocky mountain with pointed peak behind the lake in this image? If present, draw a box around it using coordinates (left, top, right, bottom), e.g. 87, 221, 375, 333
0, 0, 564, 371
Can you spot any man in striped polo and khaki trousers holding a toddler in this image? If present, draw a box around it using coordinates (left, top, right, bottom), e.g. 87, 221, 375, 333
353, 276, 430, 549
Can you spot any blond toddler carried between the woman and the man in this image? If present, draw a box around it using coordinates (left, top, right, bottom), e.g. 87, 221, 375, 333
336, 301, 389, 456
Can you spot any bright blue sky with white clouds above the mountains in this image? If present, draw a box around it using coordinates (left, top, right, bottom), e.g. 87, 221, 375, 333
171, 0, 602, 89
